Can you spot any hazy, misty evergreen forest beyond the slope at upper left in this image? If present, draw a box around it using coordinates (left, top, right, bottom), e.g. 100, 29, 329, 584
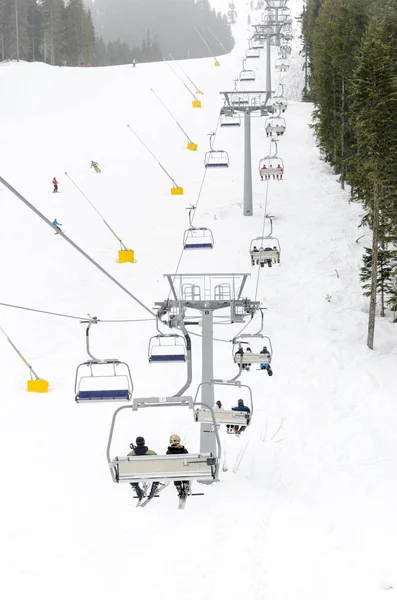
0, 0, 234, 66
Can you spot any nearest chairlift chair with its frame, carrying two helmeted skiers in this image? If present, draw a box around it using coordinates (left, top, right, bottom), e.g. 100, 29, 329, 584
106, 396, 221, 483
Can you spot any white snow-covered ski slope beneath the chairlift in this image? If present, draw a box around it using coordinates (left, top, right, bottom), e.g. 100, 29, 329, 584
0, 0, 397, 600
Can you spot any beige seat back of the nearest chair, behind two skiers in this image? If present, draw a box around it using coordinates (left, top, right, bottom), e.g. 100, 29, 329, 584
109, 453, 218, 483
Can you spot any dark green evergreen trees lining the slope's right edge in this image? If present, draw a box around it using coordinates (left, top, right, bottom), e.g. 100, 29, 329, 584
300, 0, 397, 348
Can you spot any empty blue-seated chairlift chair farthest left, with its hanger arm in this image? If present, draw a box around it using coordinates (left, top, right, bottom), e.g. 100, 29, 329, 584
74, 317, 133, 403
